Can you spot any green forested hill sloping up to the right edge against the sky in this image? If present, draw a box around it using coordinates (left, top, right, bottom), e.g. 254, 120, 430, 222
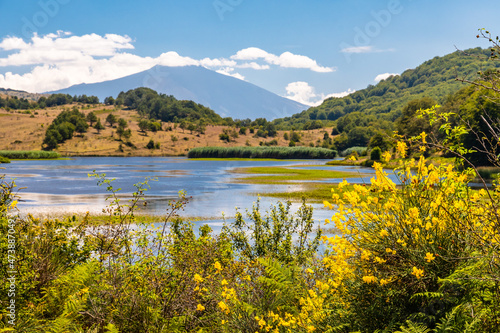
275, 48, 500, 128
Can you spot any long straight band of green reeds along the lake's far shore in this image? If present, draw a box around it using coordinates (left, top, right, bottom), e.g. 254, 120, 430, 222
188, 147, 337, 159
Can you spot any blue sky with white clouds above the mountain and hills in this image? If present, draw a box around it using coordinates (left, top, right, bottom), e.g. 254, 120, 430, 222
0, 0, 500, 104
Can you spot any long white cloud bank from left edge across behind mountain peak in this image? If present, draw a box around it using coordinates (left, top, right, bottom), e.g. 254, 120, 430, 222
0, 31, 334, 92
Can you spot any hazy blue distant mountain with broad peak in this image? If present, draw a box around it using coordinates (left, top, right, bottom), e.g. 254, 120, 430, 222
51, 66, 307, 120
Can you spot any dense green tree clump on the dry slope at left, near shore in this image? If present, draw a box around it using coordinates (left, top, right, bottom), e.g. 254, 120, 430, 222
43, 107, 89, 150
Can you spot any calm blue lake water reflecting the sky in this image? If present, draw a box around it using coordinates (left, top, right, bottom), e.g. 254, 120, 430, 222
0, 157, 386, 227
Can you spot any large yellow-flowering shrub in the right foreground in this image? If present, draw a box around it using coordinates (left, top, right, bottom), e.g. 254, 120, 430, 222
323, 140, 500, 329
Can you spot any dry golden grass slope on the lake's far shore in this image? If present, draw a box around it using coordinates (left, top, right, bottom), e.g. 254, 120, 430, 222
0, 104, 331, 156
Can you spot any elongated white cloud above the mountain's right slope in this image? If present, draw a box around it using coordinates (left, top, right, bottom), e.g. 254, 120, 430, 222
231, 47, 335, 73
